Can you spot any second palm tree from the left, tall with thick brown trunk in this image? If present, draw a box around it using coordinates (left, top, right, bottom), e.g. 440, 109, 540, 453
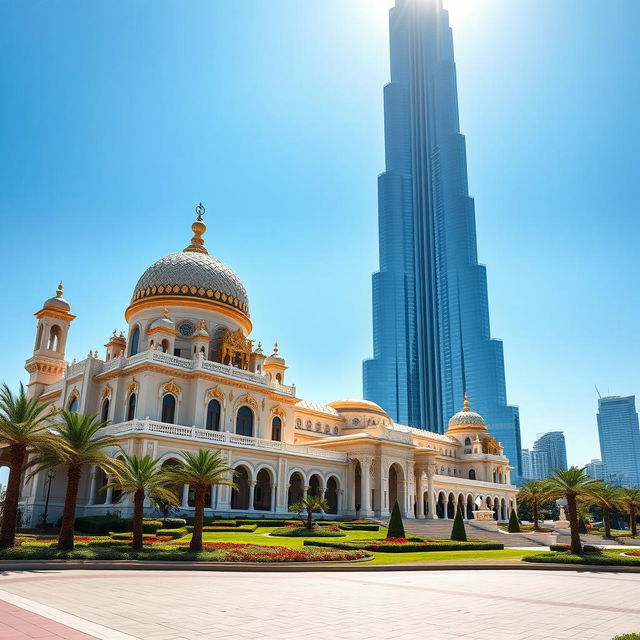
34, 409, 121, 551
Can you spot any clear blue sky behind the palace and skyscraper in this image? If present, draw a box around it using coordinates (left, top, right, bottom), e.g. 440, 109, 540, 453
0, 0, 640, 484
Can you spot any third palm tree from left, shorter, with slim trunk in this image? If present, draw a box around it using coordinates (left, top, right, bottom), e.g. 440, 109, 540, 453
107, 454, 178, 551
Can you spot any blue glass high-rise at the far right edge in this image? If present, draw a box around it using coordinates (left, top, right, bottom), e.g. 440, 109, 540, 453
598, 396, 640, 487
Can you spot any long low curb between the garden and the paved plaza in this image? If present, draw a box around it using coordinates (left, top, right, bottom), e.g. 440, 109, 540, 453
0, 560, 640, 584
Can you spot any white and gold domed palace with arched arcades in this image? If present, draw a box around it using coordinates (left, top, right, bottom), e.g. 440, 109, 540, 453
15, 205, 517, 526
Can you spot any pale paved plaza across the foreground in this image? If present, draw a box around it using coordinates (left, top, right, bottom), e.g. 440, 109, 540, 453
0, 570, 640, 640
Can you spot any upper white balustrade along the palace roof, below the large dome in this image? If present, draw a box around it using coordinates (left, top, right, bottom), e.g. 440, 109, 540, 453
95, 349, 296, 397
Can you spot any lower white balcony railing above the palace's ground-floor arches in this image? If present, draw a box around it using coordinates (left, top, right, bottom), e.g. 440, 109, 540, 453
103, 420, 347, 462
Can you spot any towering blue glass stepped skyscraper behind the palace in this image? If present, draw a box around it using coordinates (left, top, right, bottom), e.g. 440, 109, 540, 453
364, 0, 521, 482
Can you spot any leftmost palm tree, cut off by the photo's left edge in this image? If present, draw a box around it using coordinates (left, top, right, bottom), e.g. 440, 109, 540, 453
0, 383, 55, 549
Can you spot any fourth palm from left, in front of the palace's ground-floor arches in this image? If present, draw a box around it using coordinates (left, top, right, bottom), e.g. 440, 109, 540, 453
164, 449, 236, 551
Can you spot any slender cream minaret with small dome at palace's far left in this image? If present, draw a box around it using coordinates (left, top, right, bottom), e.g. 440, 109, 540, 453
25, 282, 75, 396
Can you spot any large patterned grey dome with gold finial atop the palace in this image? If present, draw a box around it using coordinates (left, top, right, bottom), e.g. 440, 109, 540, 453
131, 204, 249, 317
